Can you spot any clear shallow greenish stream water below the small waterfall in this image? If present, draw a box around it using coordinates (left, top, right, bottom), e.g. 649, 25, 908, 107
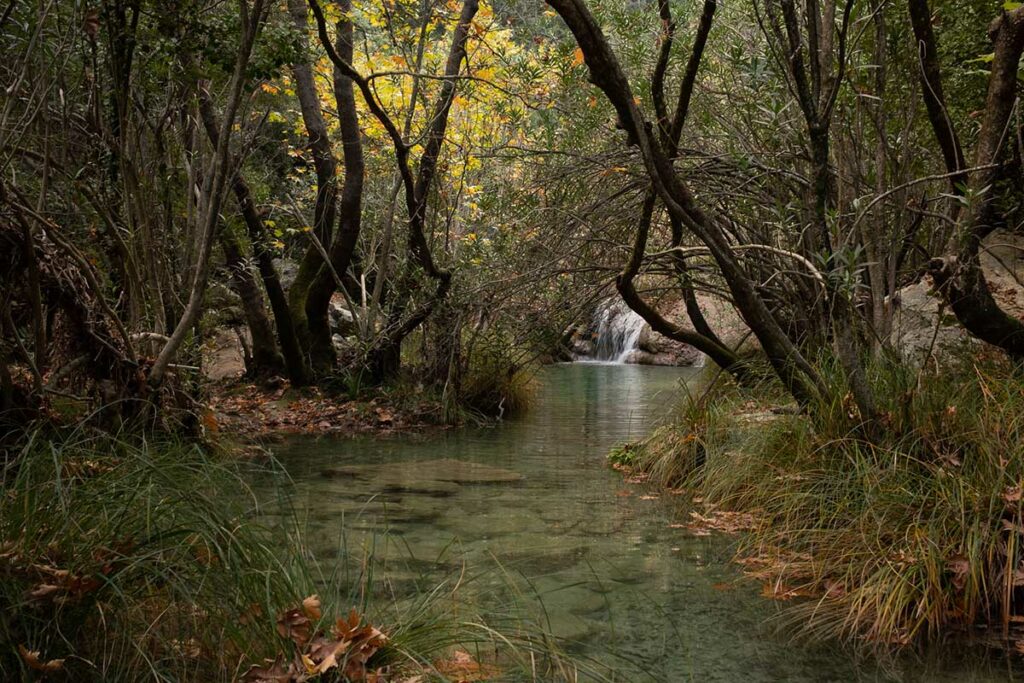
262, 364, 1015, 681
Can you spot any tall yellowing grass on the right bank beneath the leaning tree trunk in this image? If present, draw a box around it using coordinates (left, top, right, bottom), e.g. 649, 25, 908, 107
637, 360, 1024, 647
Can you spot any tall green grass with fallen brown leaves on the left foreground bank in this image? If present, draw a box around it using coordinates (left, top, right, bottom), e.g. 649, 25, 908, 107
0, 427, 589, 681
